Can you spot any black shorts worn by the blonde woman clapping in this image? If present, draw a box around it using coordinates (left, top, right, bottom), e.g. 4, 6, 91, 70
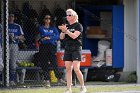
63, 49, 82, 61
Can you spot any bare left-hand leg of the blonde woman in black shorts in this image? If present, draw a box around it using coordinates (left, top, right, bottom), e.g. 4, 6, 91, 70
65, 61, 73, 90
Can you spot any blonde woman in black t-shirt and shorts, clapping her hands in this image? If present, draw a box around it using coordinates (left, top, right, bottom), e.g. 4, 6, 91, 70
59, 9, 87, 93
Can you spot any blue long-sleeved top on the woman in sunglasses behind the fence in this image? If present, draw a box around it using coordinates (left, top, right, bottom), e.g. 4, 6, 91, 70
39, 26, 59, 46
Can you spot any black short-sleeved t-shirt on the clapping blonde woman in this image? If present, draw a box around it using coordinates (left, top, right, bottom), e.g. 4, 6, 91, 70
65, 22, 83, 46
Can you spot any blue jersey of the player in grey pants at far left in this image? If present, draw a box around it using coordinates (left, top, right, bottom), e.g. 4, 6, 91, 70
8, 23, 23, 43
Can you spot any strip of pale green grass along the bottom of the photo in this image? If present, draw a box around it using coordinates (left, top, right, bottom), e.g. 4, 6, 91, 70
0, 84, 140, 93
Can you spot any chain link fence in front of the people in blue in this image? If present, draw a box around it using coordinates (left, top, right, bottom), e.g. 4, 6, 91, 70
0, 0, 74, 87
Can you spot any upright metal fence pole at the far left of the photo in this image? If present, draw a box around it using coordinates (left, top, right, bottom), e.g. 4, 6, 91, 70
2, 0, 9, 87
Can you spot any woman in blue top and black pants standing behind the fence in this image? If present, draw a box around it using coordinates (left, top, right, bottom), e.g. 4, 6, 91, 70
39, 15, 65, 87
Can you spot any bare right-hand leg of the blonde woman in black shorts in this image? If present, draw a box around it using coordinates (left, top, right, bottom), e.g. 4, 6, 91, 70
73, 61, 84, 86
